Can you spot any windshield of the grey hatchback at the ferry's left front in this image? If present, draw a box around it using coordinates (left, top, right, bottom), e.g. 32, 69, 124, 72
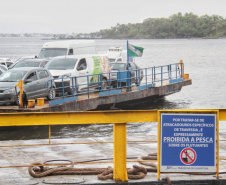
0, 71, 27, 82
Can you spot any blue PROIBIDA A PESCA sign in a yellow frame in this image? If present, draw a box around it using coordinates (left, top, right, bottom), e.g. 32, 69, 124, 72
158, 111, 219, 178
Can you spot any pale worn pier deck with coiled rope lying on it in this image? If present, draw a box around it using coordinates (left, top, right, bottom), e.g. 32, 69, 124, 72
0, 123, 226, 185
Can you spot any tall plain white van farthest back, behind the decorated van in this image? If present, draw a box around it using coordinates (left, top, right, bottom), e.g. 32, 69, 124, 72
38, 40, 97, 58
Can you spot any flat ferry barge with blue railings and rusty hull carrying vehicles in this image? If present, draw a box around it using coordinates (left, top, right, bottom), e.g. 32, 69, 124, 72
0, 61, 192, 113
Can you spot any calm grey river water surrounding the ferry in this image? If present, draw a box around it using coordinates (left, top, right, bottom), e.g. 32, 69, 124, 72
0, 38, 226, 139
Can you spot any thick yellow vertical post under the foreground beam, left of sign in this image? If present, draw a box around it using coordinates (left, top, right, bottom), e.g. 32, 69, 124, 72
114, 123, 128, 182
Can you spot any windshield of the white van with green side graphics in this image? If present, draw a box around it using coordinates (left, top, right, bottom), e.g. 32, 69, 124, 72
46, 58, 78, 70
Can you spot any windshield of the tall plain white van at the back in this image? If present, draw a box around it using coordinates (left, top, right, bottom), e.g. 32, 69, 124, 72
38, 48, 67, 58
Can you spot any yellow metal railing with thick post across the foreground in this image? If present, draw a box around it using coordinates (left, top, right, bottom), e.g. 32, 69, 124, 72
0, 109, 226, 181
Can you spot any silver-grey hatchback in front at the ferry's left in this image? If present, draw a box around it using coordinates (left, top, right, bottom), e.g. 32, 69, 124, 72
0, 67, 56, 104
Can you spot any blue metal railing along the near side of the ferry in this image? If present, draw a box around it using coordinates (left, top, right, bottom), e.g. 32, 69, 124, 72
47, 62, 184, 98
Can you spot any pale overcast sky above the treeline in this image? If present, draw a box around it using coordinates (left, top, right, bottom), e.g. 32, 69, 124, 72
0, 0, 226, 34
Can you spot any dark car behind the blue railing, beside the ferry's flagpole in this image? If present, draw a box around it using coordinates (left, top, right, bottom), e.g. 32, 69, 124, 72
110, 62, 144, 87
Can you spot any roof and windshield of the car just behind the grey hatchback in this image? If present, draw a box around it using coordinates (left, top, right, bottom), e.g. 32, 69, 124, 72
9, 59, 49, 69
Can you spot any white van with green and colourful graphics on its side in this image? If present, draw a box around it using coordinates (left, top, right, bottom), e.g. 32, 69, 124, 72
46, 54, 111, 94
